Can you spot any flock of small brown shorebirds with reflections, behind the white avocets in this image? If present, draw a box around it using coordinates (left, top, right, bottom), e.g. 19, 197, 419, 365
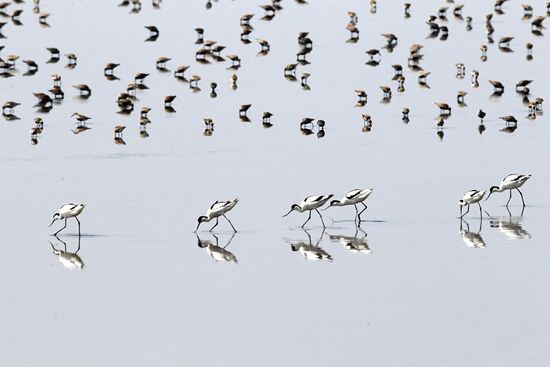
0, 0, 550, 145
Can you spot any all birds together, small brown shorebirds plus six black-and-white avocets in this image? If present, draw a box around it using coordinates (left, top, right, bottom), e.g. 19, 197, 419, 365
0, 0, 550, 264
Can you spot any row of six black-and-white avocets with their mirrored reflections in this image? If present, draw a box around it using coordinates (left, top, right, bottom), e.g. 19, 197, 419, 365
50, 174, 531, 269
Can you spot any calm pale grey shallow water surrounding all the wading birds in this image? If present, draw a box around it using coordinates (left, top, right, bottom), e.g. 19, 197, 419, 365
0, 0, 550, 366
